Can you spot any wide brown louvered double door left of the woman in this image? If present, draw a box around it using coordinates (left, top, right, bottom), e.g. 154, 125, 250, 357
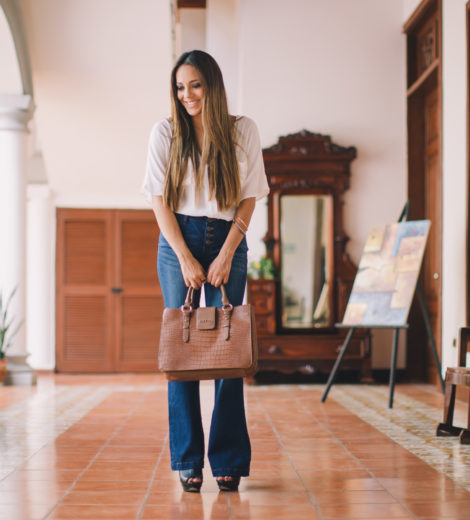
56, 209, 163, 372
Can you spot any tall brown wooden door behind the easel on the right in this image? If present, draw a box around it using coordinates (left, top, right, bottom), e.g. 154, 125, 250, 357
404, 0, 444, 383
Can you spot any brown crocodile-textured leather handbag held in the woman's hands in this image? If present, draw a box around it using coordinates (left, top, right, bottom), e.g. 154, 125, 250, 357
158, 285, 258, 381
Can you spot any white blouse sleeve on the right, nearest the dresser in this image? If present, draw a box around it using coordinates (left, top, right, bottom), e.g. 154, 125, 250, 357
239, 117, 269, 200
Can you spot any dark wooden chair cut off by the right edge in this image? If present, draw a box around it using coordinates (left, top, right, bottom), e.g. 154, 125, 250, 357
436, 327, 470, 444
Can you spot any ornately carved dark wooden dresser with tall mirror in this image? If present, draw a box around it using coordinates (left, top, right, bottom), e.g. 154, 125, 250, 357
248, 130, 370, 379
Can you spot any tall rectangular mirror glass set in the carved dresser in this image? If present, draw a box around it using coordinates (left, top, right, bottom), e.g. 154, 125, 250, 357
279, 193, 334, 329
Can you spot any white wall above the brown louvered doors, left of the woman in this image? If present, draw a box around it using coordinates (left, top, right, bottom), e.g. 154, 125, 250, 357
21, 0, 172, 207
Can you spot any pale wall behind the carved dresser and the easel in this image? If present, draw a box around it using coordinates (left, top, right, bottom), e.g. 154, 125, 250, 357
238, 0, 407, 368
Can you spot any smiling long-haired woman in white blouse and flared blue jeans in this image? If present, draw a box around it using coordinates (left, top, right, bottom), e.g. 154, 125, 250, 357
143, 50, 269, 492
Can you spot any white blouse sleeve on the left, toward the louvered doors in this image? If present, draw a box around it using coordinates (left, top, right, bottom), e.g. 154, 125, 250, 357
141, 119, 171, 203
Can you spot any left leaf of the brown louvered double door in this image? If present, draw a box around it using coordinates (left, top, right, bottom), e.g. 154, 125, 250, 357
56, 209, 113, 372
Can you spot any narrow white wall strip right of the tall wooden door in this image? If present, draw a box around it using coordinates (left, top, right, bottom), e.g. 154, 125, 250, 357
442, 0, 468, 373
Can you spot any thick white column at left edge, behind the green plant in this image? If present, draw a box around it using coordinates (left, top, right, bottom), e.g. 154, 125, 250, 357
0, 96, 35, 384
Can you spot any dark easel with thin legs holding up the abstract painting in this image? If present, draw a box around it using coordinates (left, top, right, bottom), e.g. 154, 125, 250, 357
321, 201, 444, 408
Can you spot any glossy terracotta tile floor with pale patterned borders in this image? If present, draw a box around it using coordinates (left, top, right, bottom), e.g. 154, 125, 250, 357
0, 374, 470, 520
